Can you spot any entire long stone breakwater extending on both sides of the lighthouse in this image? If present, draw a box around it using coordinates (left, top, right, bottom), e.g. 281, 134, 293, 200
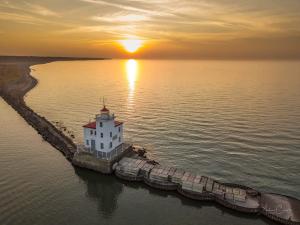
1, 59, 299, 224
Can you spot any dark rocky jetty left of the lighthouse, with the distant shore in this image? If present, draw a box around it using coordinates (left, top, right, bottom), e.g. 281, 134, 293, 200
0, 57, 103, 161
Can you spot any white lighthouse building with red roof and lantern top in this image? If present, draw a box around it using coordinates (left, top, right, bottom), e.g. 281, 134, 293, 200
83, 105, 123, 155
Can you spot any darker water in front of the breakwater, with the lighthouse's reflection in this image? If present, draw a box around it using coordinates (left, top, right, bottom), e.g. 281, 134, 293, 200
0, 99, 273, 225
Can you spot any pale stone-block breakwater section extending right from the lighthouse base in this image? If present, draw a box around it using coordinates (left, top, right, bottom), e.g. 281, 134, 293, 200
114, 157, 300, 224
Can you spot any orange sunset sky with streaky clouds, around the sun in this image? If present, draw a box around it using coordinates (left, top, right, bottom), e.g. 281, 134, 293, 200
0, 0, 300, 59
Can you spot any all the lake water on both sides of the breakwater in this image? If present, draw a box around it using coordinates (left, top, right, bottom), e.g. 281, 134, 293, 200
0, 60, 300, 225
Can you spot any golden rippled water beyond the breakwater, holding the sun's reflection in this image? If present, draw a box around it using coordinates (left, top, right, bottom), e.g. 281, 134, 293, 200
26, 60, 300, 198
